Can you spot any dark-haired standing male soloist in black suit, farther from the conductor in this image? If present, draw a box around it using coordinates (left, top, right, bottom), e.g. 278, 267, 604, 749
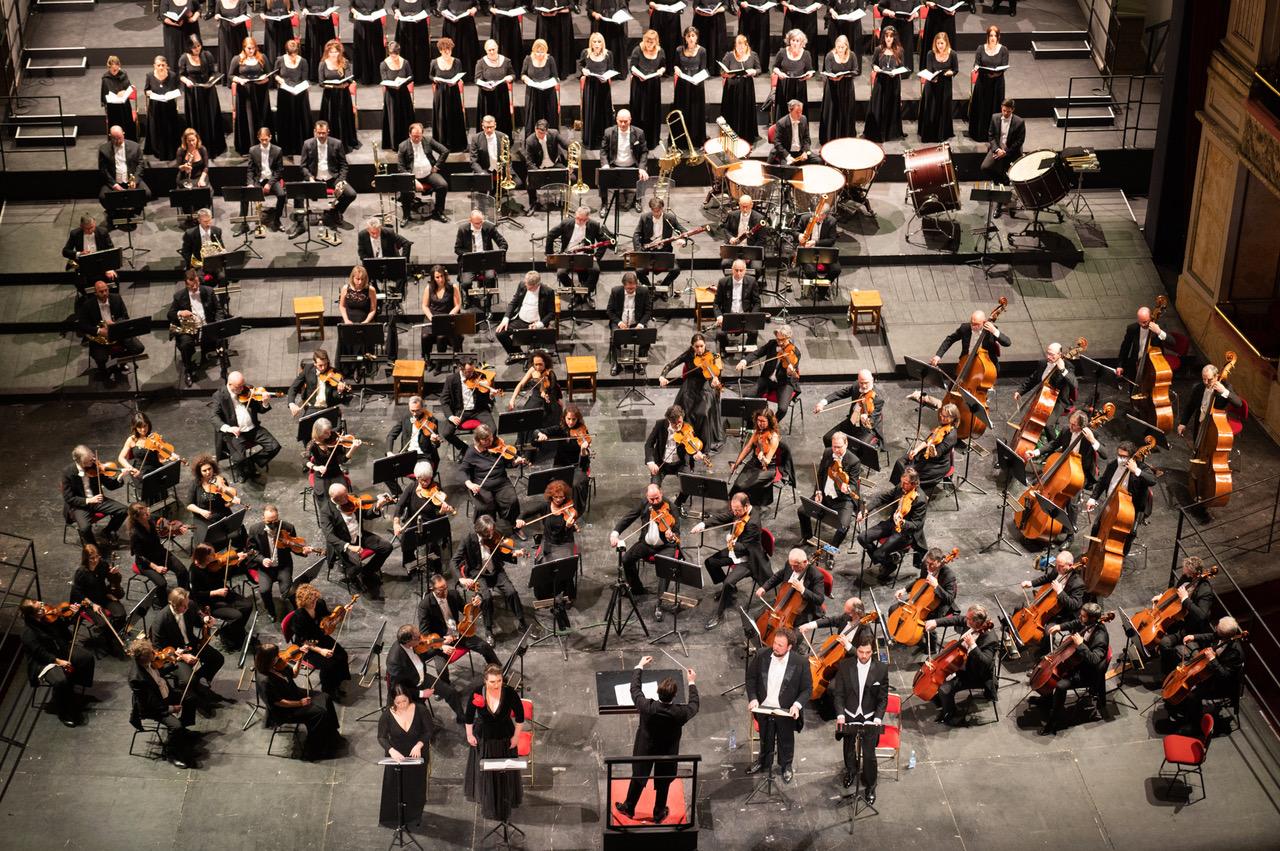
831, 627, 888, 804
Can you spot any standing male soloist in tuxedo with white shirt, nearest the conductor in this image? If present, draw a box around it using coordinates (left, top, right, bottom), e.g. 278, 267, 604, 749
746, 628, 813, 783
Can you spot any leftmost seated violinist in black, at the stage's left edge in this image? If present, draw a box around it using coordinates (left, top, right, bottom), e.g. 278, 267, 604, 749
18, 600, 96, 727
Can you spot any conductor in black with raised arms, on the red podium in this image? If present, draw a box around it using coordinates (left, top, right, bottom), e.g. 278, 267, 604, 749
613, 656, 699, 824
